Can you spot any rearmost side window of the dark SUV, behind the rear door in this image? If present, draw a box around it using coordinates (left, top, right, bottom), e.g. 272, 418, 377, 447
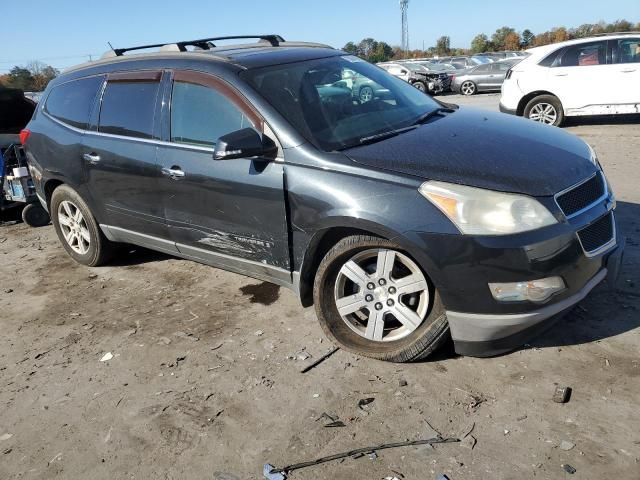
45, 77, 103, 129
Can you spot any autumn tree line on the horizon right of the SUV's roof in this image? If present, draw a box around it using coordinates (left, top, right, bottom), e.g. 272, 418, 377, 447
343, 20, 640, 63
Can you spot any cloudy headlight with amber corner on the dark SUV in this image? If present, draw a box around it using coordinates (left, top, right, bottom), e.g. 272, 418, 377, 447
420, 181, 558, 235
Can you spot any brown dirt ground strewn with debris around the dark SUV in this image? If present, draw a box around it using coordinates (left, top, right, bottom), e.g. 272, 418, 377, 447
0, 95, 640, 480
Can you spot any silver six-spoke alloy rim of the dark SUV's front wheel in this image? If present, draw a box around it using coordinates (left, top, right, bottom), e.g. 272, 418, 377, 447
334, 249, 430, 342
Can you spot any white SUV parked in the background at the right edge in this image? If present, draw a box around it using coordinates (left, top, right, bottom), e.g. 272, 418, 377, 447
500, 32, 640, 126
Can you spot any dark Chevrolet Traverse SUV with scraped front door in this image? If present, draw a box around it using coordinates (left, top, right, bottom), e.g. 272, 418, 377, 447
23, 35, 623, 361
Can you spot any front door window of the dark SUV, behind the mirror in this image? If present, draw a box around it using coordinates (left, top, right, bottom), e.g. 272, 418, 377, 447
171, 82, 255, 146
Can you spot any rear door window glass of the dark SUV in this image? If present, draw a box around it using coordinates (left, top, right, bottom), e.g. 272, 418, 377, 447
98, 81, 160, 138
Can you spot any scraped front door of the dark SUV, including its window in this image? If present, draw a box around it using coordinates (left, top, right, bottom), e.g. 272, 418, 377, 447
158, 71, 291, 281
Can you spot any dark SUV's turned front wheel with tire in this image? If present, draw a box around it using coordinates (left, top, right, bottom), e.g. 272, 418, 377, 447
313, 235, 449, 362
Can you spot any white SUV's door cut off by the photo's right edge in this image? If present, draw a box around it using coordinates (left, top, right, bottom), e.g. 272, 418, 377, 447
609, 36, 640, 113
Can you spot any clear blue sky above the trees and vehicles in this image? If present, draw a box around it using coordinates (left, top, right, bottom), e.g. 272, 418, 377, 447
0, 0, 640, 73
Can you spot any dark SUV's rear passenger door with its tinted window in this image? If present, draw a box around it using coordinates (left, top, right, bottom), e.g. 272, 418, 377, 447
82, 71, 168, 239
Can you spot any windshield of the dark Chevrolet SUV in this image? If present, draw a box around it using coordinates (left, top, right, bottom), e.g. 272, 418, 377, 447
241, 56, 441, 151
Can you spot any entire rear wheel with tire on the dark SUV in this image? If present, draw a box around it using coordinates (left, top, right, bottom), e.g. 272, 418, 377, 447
49, 185, 114, 267
